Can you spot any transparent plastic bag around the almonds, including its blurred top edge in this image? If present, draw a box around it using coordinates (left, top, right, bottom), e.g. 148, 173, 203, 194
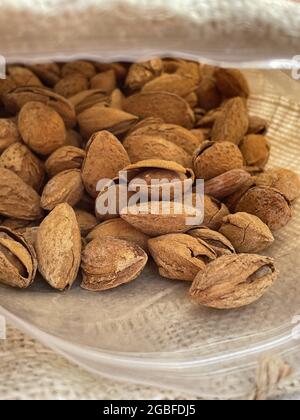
0, 0, 300, 398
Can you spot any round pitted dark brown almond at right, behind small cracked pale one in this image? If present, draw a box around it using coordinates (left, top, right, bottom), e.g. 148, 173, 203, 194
236, 187, 292, 231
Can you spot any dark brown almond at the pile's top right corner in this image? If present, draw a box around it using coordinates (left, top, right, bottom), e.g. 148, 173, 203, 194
215, 68, 250, 98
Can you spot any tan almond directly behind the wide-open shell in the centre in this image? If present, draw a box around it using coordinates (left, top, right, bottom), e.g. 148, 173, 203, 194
123, 134, 192, 167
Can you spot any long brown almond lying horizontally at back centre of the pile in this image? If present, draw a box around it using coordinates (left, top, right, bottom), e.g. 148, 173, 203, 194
124, 92, 195, 128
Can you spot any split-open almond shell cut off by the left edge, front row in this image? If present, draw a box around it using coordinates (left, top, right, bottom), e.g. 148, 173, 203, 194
0, 226, 37, 289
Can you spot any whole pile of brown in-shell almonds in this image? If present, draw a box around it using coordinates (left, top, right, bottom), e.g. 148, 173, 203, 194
0, 58, 300, 309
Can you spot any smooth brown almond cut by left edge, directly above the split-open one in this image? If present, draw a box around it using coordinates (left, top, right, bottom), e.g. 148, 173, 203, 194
0, 168, 43, 220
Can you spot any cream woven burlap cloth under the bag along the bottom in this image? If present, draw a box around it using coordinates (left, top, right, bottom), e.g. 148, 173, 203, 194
0, 325, 300, 400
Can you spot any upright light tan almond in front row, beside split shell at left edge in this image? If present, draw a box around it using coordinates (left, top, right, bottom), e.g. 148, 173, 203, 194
36, 203, 81, 290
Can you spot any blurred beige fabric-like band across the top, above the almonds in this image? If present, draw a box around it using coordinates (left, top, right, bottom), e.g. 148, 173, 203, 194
0, 0, 300, 65
